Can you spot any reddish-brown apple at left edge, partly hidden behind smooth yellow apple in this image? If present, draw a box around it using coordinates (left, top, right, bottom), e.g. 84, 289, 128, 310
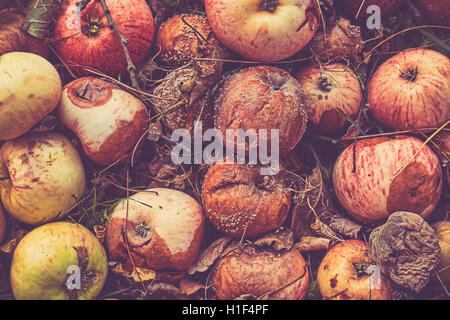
0, 10, 48, 58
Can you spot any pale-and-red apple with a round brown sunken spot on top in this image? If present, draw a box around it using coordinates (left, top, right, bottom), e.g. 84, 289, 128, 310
56, 77, 150, 166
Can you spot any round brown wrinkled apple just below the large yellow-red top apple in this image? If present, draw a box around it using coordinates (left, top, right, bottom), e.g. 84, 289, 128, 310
215, 66, 309, 154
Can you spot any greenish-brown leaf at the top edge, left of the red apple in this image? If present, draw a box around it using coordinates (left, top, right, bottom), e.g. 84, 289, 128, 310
23, 0, 59, 39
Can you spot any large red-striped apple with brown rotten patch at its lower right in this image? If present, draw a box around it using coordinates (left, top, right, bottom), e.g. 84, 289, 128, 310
333, 136, 442, 223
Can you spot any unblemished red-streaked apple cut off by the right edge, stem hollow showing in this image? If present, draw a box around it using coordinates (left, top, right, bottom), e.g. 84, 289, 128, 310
367, 48, 450, 130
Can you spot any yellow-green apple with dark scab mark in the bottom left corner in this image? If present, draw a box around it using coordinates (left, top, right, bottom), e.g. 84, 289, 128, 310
10, 222, 108, 300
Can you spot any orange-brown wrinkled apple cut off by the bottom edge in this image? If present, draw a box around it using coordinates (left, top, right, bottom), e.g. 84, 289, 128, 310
211, 244, 309, 300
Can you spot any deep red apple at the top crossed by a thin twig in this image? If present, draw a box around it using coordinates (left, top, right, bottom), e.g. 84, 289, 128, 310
54, 0, 155, 78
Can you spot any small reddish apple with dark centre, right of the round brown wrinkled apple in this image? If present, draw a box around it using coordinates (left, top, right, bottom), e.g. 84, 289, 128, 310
294, 63, 363, 135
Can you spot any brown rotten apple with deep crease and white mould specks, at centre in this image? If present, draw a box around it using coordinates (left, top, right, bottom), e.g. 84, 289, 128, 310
202, 163, 292, 238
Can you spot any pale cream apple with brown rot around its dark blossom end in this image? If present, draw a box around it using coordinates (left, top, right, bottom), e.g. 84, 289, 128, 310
106, 188, 205, 270
